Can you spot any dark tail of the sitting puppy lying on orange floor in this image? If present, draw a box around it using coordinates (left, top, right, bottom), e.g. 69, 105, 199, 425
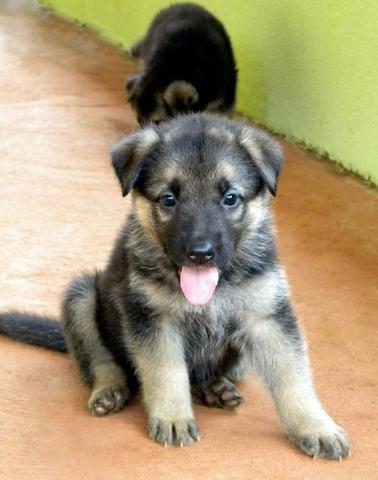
0, 312, 67, 353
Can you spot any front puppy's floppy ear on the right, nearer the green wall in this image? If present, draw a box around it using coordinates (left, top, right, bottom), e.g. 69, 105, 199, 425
239, 126, 282, 196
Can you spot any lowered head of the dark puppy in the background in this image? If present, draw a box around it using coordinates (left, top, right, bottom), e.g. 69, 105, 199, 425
125, 74, 199, 124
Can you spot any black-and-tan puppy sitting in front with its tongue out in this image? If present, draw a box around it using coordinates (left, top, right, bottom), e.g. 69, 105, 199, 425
0, 114, 349, 458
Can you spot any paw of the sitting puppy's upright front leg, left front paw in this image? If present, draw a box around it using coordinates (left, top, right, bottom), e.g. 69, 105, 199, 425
148, 417, 200, 447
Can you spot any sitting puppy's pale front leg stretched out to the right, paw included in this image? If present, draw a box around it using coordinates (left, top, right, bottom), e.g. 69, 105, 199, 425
252, 304, 350, 458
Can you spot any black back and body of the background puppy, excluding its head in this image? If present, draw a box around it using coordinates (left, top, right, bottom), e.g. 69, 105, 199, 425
138, 3, 236, 110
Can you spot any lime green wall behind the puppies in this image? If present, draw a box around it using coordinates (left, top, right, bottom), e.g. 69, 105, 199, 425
41, 0, 378, 184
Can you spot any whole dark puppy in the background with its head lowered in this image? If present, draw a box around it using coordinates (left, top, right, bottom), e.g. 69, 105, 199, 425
126, 3, 236, 123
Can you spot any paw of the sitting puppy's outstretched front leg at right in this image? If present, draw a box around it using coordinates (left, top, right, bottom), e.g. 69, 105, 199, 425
289, 424, 351, 459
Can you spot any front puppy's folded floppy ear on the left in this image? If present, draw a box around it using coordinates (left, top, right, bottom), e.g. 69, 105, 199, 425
111, 127, 160, 196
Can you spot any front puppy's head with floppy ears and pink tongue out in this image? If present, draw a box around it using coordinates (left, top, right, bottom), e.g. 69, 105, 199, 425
112, 114, 281, 304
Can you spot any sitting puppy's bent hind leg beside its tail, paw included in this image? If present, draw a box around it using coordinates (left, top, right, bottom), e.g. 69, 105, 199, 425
63, 275, 129, 416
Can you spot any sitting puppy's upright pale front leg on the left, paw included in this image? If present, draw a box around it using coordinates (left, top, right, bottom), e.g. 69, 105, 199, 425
134, 322, 199, 446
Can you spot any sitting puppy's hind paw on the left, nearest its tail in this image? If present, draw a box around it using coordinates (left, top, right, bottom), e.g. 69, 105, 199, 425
88, 385, 129, 417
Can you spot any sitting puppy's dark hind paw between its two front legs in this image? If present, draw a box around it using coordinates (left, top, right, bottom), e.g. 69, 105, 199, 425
193, 378, 244, 410
